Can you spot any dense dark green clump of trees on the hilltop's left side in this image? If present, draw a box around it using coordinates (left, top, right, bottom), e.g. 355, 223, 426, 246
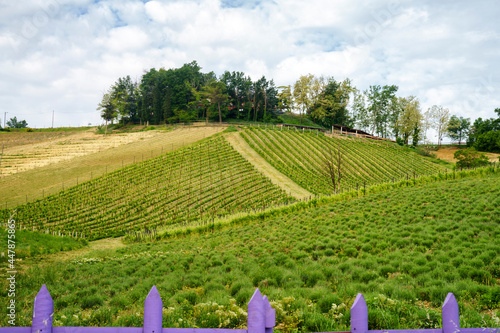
98, 61, 278, 124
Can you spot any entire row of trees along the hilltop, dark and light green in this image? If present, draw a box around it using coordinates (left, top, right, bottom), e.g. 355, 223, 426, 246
98, 61, 500, 151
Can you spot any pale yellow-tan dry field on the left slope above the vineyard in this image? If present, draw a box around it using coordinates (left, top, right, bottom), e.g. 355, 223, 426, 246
0, 127, 224, 208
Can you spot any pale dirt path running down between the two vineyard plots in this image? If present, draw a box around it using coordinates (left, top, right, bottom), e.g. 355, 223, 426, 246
224, 132, 313, 199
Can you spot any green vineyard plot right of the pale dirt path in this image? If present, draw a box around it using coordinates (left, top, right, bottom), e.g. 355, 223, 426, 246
241, 127, 445, 194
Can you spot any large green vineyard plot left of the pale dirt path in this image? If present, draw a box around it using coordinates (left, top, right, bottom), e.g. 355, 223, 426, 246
0, 136, 294, 239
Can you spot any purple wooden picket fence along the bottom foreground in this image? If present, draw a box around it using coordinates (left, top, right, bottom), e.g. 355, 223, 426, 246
0, 285, 500, 333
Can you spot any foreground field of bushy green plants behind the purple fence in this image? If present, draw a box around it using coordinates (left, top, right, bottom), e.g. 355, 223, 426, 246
0, 169, 500, 331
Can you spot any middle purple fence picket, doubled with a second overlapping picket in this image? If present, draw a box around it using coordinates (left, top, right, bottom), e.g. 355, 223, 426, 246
247, 288, 276, 333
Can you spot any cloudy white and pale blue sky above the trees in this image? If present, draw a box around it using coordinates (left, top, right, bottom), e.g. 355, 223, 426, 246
0, 0, 500, 136
